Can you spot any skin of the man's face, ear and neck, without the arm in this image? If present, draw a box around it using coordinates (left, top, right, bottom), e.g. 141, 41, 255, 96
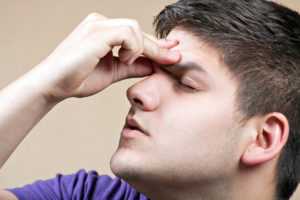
111, 28, 288, 200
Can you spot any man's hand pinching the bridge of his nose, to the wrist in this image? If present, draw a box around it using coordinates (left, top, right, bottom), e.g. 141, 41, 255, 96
33, 13, 180, 101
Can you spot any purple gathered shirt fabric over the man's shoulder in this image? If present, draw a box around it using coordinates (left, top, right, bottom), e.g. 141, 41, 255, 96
8, 170, 149, 200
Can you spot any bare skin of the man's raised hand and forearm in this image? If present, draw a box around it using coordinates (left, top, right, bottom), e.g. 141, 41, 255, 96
0, 13, 180, 200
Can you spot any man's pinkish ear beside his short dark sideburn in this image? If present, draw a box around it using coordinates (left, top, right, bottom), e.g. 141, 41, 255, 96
241, 112, 289, 166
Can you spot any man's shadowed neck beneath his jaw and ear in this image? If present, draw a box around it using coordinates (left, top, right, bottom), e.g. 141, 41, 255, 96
125, 162, 276, 200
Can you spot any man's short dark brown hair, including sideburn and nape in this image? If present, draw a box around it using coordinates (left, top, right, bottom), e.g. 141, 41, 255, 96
154, 0, 300, 199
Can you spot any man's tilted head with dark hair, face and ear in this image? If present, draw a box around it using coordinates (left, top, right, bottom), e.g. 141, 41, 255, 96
111, 0, 300, 199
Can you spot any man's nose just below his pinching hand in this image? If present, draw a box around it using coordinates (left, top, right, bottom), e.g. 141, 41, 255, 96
127, 67, 160, 111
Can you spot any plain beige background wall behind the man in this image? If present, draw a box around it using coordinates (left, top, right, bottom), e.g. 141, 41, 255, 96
0, 0, 300, 198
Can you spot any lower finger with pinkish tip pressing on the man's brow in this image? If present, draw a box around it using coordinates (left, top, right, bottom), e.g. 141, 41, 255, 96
143, 36, 181, 64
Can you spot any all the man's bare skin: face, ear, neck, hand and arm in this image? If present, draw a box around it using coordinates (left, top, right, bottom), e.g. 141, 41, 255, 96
0, 13, 289, 200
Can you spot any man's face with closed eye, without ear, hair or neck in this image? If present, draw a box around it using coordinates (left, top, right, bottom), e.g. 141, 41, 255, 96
111, 29, 241, 185
